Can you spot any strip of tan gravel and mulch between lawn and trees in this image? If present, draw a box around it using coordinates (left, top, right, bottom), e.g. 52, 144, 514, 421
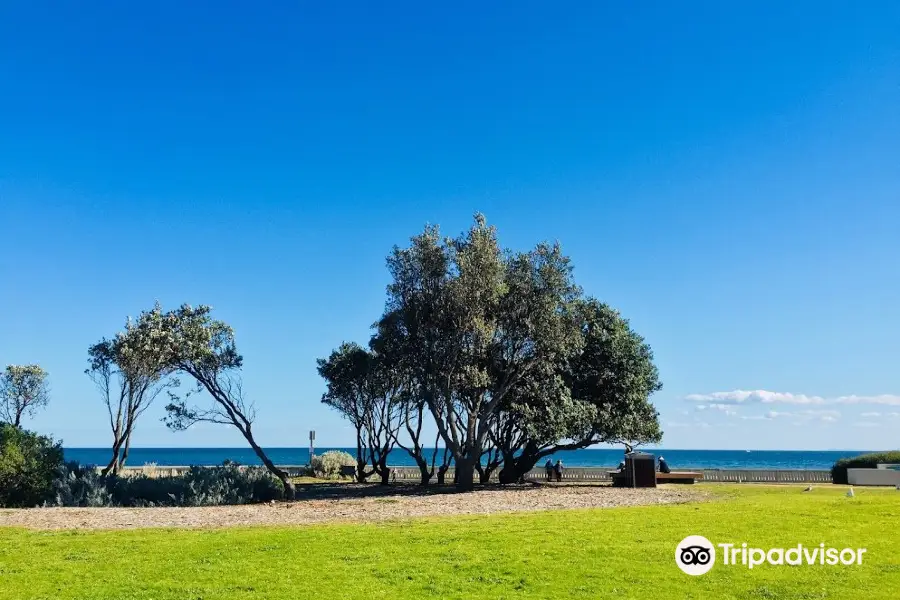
0, 484, 706, 529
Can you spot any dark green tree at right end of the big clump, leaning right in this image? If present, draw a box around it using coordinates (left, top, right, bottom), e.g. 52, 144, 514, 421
492, 299, 662, 483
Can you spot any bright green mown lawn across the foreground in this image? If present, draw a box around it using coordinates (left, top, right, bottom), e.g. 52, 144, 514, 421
0, 485, 900, 600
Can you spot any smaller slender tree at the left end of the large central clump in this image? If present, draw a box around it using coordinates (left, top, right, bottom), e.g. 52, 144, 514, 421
318, 342, 404, 484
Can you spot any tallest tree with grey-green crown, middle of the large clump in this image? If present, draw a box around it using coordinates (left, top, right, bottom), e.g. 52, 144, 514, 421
381, 215, 579, 490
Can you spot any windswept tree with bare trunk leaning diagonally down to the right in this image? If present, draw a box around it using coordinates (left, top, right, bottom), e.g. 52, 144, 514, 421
144, 304, 294, 499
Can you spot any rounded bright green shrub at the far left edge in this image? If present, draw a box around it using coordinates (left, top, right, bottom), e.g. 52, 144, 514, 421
0, 423, 63, 507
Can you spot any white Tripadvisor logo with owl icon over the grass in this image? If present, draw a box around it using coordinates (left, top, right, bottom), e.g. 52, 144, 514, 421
675, 535, 866, 575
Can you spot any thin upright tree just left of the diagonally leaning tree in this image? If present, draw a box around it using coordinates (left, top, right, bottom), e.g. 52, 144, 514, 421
85, 304, 179, 475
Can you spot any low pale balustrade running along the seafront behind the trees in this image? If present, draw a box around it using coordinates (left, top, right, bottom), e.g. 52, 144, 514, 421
114, 465, 831, 483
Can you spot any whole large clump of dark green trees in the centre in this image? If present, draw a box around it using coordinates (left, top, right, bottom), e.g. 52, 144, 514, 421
319, 214, 662, 490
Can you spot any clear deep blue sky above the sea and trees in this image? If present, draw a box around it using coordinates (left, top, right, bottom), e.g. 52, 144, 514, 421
0, 1, 900, 449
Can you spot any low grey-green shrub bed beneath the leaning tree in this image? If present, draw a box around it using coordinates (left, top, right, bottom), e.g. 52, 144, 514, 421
47, 463, 284, 506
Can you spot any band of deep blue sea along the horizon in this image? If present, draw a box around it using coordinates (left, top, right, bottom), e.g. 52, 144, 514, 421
65, 448, 863, 469
